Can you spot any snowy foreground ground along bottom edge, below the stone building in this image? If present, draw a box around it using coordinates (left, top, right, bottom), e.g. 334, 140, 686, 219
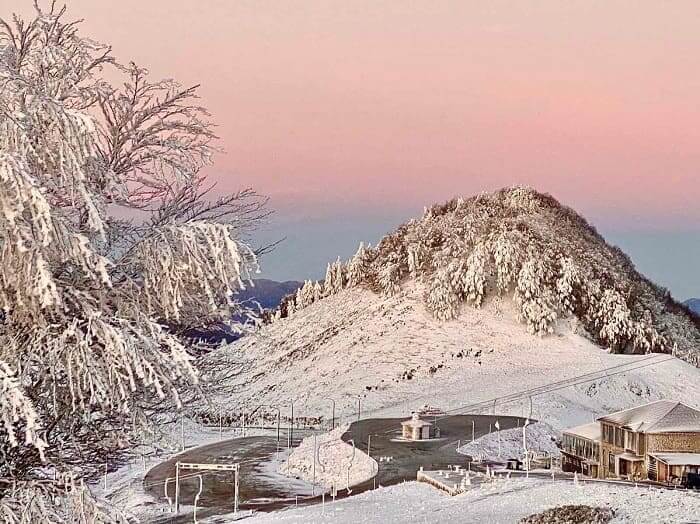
234, 478, 700, 524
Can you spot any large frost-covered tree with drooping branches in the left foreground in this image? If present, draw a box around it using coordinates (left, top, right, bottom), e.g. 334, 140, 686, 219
0, 6, 265, 521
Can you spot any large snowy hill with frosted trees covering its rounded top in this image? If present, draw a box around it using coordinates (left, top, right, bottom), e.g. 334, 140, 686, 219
197, 189, 700, 429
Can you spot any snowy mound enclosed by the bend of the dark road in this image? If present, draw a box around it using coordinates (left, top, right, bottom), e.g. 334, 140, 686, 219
280, 426, 377, 488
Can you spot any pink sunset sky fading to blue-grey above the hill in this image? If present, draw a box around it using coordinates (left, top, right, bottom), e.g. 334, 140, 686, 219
12, 0, 700, 299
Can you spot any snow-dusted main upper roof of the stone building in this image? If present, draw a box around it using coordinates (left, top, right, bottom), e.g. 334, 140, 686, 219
598, 400, 700, 433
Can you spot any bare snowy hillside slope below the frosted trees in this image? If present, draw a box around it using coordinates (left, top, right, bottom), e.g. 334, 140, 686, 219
201, 281, 700, 430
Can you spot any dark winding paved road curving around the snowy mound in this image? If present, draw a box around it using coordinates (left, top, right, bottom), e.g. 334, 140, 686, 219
144, 415, 523, 522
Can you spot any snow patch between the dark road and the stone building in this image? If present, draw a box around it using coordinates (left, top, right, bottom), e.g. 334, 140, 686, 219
458, 422, 559, 460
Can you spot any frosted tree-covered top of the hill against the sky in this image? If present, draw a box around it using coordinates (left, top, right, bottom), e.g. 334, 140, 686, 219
278, 187, 700, 365
